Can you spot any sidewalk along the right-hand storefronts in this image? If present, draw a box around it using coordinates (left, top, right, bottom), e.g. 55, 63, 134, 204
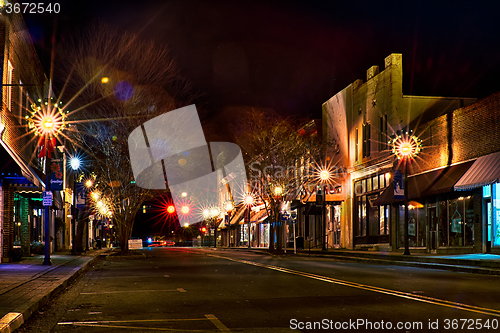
219, 247, 500, 275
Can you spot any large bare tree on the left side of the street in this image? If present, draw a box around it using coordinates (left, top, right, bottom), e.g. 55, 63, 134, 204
57, 23, 194, 252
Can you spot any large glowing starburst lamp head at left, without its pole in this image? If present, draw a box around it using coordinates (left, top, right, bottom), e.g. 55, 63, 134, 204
26, 99, 66, 137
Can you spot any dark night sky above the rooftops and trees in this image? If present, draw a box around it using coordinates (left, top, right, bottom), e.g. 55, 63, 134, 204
26, 0, 500, 117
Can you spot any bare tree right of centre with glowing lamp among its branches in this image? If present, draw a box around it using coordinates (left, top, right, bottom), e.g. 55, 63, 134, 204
232, 110, 332, 250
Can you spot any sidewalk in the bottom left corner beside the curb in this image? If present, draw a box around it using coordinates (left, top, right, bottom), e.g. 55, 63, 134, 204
0, 249, 109, 333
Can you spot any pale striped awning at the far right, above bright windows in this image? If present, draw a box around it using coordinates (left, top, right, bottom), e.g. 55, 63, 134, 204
454, 152, 500, 191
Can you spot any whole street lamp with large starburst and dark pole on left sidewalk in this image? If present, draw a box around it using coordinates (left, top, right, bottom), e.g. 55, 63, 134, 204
26, 98, 66, 265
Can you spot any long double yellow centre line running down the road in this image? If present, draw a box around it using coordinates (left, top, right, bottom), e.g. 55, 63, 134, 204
207, 254, 500, 317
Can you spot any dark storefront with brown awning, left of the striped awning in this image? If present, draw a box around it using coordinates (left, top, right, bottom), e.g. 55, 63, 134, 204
373, 161, 481, 253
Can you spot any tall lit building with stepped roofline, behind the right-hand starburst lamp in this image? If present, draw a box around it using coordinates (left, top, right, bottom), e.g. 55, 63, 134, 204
323, 54, 475, 250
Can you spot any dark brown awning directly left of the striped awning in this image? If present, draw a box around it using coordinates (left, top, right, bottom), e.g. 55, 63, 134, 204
373, 161, 474, 206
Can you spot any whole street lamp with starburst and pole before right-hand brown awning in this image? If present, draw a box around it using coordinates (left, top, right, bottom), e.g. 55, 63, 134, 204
390, 131, 422, 255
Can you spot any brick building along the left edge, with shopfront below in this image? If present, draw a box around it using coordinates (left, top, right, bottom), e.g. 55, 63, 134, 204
0, 13, 57, 262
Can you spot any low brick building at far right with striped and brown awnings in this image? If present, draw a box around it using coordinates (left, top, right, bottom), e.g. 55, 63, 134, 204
374, 93, 500, 253
